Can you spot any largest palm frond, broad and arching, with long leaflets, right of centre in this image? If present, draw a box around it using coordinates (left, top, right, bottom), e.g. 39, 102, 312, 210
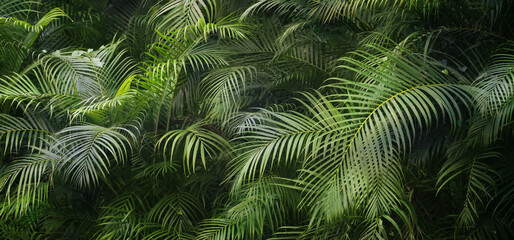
228, 42, 470, 237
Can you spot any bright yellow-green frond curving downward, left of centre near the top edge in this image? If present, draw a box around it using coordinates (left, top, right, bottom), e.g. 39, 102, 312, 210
138, 20, 244, 134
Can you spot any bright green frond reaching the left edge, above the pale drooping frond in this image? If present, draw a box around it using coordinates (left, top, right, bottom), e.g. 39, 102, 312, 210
0, 51, 97, 117
